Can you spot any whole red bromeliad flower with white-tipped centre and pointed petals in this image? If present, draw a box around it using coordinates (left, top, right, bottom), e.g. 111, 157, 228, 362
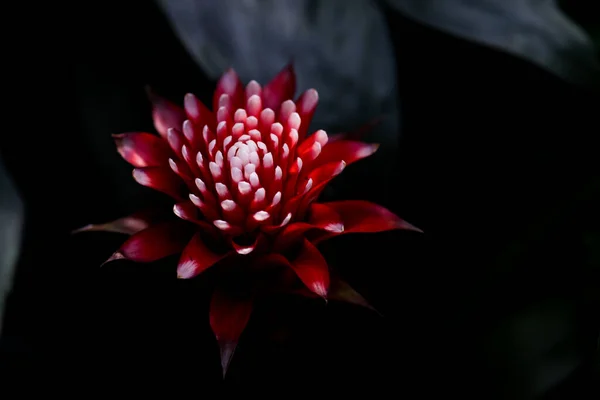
77, 66, 418, 371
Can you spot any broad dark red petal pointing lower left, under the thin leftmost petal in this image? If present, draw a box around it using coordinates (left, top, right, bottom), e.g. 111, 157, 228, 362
105, 221, 191, 264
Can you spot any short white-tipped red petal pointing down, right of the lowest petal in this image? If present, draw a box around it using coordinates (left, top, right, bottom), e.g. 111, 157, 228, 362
290, 239, 329, 298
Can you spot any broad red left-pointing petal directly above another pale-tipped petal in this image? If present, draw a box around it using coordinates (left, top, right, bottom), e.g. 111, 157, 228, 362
113, 132, 170, 168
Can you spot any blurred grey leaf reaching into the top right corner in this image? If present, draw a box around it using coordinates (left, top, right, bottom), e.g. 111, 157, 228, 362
385, 0, 600, 83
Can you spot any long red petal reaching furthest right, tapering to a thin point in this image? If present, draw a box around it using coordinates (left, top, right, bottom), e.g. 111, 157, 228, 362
313, 200, 422, 243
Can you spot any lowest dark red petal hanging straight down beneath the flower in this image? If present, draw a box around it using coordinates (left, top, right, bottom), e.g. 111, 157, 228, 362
210, 289, 252, 377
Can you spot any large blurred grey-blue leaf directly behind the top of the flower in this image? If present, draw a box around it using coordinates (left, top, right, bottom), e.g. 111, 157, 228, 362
159, 0, 398, 145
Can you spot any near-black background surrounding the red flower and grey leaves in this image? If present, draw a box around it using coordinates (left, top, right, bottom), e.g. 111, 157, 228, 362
0, 1, 600, 399
